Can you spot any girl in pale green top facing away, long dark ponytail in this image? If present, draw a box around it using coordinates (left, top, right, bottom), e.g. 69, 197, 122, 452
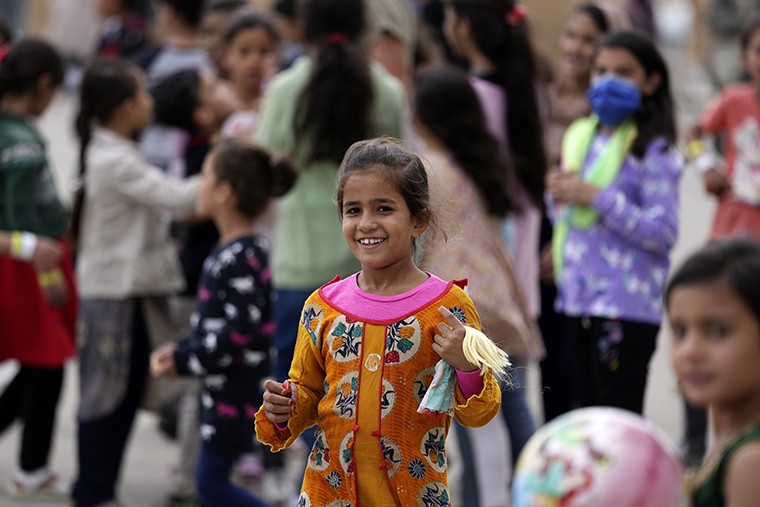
257, 0, 404, 408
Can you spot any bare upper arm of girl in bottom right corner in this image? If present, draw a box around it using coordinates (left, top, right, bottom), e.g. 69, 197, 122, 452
723, 442, 760, 507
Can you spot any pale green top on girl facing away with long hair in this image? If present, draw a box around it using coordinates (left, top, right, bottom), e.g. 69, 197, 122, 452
257, 57, 404, 290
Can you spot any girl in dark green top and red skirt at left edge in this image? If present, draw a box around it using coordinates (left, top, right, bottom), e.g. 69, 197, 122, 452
0, 39, 72, 501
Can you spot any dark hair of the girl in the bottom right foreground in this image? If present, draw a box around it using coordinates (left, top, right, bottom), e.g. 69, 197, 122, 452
664, 238, 760, 321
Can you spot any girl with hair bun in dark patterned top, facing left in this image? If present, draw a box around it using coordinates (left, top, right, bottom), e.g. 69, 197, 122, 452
151, 140, 297, 507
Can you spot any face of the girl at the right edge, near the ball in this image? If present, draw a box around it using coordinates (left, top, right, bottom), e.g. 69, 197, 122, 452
668, 282, 760, 408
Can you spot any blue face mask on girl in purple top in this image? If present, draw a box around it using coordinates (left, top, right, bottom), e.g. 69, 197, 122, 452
587, 76, 641, 127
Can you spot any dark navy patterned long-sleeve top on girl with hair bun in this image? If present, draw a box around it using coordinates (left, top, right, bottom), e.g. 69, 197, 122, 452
174, 236, 274, 452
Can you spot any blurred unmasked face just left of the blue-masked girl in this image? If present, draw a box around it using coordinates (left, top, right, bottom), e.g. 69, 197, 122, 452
559, 12, 602, 80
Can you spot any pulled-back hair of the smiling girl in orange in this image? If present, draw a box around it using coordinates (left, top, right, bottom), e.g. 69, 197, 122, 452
336, 137, 435, 235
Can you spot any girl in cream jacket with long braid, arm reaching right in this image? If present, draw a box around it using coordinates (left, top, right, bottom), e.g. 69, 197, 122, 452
72, 58, 198, 507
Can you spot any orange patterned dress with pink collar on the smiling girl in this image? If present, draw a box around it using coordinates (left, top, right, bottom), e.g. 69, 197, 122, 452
256, 275, 501, 507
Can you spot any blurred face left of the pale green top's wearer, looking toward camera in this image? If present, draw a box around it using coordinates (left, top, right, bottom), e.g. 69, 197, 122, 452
224, 28, 277, 96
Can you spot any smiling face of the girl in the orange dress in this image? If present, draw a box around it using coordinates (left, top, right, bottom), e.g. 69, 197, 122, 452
341, 170, 427, 271
